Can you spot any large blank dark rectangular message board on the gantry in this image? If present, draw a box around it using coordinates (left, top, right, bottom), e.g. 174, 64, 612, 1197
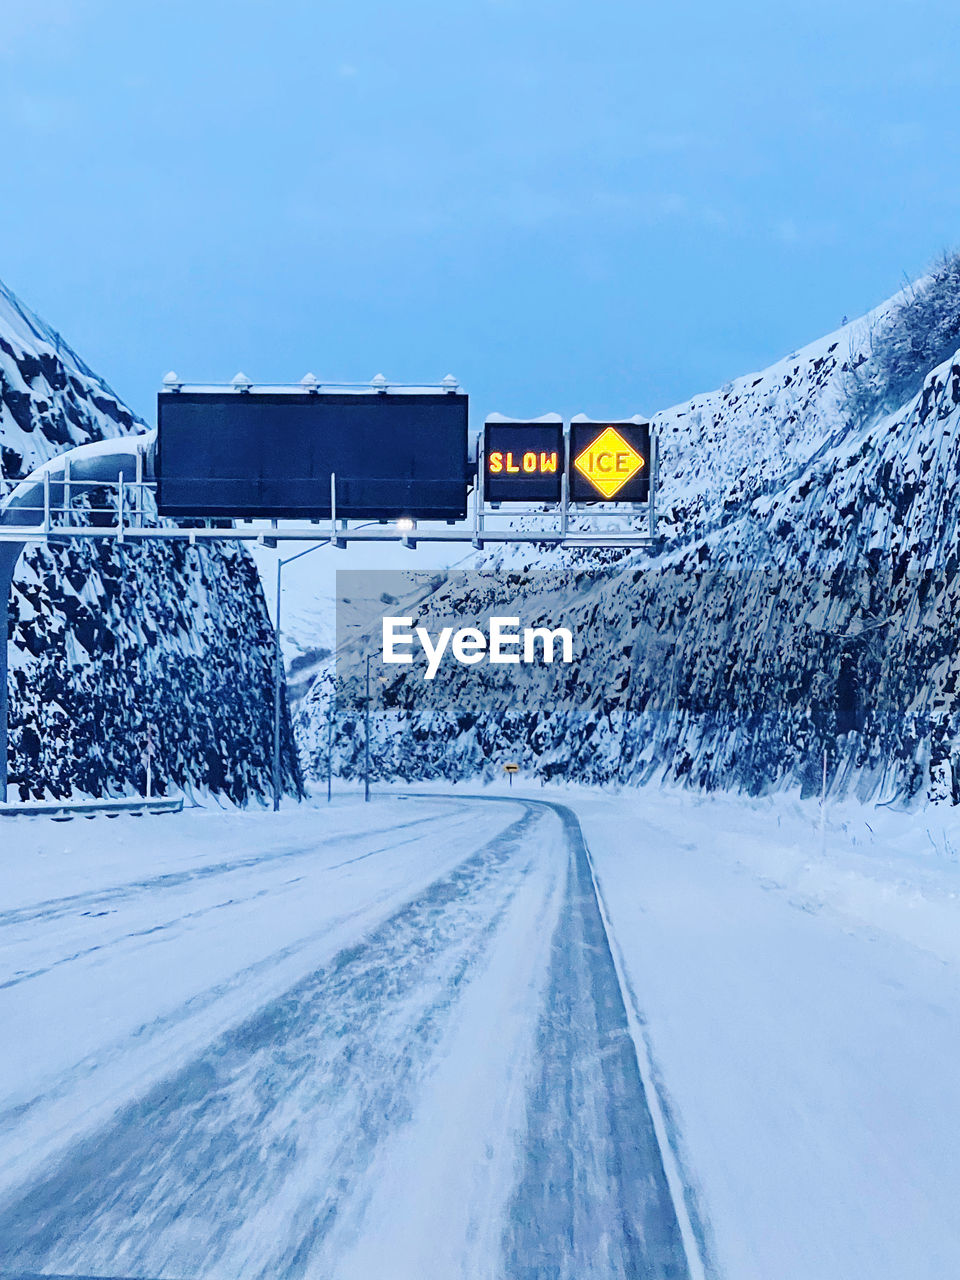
156, 390, 470, 520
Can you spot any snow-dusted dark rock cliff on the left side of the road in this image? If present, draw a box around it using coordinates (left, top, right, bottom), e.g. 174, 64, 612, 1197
0, 284, 298, 803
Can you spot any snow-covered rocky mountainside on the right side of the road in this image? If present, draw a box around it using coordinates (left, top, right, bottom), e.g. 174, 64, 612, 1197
300, 259, 960, 803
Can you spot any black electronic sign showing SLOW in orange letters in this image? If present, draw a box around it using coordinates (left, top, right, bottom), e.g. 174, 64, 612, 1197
484, 419, 563, 503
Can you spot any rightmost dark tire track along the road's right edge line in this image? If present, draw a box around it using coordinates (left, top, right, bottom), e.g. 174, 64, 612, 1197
502, 803, 691, 1280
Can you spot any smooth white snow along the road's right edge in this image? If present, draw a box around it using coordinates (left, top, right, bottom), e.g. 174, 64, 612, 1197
572, 790, 960, 1280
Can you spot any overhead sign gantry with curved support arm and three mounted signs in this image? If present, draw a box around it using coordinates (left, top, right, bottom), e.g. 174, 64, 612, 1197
0, 374, 657, 548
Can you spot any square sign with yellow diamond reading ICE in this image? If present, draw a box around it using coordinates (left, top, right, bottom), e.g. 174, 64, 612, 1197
570, 419, 650, 502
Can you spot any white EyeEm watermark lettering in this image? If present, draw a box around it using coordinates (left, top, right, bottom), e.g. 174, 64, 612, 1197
383, 617, 573, 680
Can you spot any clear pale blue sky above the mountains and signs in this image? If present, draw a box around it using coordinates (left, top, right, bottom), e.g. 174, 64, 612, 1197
0, 0, 960, 420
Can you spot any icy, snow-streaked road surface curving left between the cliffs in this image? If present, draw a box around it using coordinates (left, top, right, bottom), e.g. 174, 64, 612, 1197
0, 799, 699, 1280
